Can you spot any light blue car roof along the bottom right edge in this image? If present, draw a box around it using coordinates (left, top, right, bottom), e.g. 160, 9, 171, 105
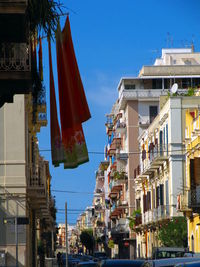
142, 257, 200, 267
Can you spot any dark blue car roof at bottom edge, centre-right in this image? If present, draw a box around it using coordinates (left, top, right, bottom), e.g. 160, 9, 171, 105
100, 260, 145, 267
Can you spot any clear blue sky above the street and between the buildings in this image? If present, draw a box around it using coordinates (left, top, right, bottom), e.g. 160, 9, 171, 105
38, 0, 200, 224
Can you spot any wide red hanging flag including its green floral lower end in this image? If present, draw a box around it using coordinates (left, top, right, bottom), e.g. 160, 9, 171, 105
56, 17, 91, 168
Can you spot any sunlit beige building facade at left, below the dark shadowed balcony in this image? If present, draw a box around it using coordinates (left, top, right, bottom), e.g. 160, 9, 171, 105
0, 95, 55, 266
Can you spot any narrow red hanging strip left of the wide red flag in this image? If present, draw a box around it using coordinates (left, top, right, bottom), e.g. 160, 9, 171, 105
48, 39, 65, 167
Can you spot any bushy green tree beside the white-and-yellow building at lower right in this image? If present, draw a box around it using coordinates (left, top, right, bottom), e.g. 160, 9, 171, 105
158, 217, 187, 247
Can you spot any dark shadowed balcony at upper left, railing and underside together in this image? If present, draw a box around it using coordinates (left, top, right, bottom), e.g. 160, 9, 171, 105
0, 43, 31, 105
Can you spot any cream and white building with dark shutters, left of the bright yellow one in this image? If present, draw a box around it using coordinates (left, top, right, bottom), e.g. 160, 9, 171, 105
135, 96, 199, 257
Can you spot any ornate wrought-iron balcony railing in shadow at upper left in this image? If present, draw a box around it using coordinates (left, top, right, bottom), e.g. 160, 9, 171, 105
0, 43, 31, 72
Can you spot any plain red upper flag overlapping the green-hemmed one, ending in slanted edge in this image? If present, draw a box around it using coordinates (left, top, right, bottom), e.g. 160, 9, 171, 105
56, 17, 91, 130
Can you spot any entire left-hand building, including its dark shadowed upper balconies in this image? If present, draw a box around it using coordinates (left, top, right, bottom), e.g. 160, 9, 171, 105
0, 0, 55, 266
